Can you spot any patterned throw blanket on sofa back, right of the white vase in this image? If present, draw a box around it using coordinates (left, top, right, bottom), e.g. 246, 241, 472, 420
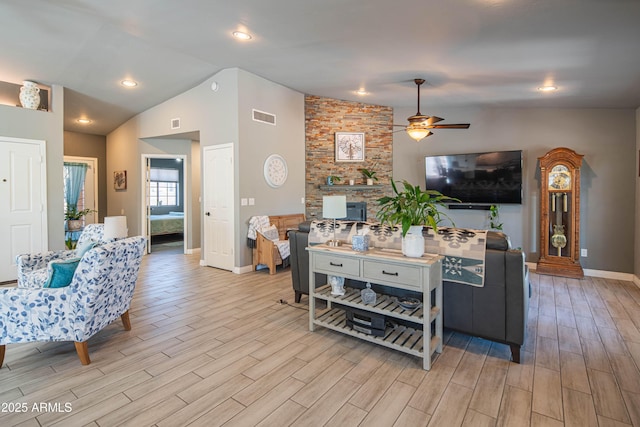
423, 227, 487, 287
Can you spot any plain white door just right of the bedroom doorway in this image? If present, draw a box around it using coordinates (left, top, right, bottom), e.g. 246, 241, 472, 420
203, 144, 234, 270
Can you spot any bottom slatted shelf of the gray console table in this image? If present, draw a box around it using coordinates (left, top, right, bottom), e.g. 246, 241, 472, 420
313, 308, 441, 357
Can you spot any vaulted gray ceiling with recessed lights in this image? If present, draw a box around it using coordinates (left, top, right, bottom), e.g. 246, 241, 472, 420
0, 0, 640, 134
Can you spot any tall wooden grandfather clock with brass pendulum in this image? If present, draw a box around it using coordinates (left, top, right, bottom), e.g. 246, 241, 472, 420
536, 147, 584, 278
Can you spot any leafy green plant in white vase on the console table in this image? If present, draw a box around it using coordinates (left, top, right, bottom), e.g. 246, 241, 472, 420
376, 180, 460, 237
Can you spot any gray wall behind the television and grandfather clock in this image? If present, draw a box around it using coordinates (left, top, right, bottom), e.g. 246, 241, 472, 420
393, 108, 640, 273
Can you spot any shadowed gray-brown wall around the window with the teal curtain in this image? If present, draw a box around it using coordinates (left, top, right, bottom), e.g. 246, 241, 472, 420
64, 131, 107, 222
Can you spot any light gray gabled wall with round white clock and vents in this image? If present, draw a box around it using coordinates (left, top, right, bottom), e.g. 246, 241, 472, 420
107, 69, 304, 267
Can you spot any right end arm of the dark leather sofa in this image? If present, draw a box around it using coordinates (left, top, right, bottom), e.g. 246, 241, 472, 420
505, 250, 529, 344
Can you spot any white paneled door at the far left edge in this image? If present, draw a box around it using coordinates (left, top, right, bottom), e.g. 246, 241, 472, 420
0, 137, 47, 282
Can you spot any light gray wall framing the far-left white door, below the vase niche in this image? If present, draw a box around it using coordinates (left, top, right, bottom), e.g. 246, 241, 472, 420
0, 85, 65, 250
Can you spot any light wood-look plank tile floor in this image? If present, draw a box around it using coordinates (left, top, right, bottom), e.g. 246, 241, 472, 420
0, 252, 640, 427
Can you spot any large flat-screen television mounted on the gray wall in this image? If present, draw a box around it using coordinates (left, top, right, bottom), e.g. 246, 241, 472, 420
425, 150, 522, 204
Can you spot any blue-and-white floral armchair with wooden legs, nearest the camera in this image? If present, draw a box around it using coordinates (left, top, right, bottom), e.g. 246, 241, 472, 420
0, 236, 146, 367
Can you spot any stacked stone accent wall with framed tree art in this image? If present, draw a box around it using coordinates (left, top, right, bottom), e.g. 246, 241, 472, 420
305, 95, 393, 221
